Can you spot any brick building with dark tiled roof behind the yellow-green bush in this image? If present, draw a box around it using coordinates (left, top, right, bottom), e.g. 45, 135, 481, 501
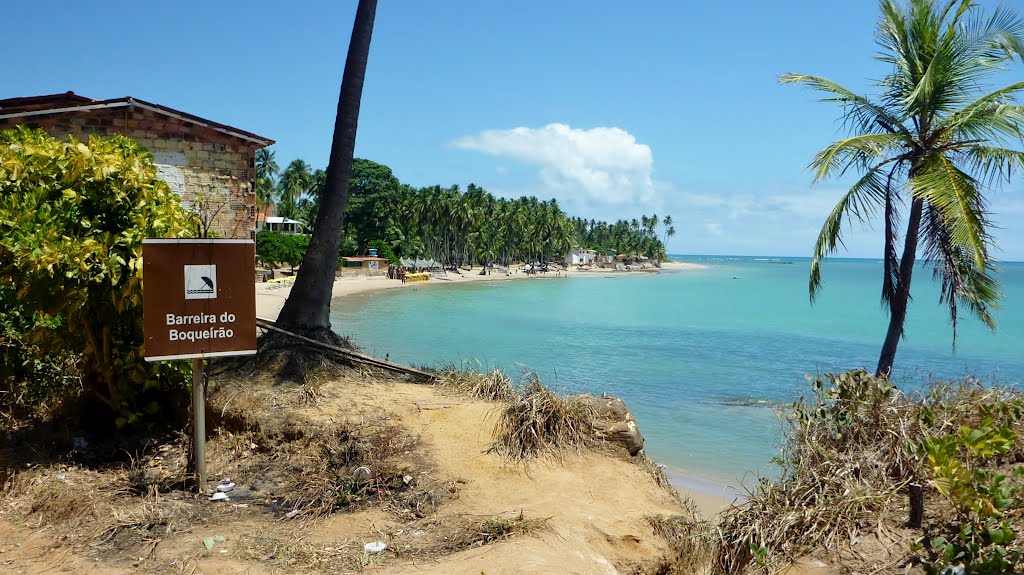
0, 92, 273, 237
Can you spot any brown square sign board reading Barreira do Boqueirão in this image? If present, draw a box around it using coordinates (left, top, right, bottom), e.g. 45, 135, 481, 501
142, 239, 256, 361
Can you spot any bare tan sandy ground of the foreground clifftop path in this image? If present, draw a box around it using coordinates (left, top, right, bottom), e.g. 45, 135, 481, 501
0, 379, 737, 575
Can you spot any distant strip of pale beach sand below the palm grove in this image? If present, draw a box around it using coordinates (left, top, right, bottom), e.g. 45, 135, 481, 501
256, 262, 705, 319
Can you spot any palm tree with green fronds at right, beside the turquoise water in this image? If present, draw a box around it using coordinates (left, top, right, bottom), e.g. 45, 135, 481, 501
780, 0, 1024, 375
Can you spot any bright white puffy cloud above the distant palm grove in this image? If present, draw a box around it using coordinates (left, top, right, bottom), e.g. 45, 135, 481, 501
453, 124, 655, 205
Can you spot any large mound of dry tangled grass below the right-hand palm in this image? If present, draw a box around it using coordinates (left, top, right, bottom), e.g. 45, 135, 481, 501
687, 371, 1024, 574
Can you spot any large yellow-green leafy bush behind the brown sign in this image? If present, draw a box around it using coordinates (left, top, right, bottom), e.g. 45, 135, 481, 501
0, 128, 195, 424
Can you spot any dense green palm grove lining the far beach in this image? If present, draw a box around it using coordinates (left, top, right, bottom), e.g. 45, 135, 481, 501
256, 149, 675, 266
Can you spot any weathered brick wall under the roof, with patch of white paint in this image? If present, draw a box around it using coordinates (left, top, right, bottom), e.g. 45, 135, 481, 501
0, 106, 258, 237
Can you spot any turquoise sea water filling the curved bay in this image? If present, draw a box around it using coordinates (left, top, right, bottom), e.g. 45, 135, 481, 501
332, 256, 1024, 485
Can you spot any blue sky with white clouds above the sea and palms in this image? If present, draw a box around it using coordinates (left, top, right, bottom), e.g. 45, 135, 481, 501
0, 0, 1024, 255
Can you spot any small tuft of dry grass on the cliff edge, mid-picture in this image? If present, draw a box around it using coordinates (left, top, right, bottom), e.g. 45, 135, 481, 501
490, 373, 595, 461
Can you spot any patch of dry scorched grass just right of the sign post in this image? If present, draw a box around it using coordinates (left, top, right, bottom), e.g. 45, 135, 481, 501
208, 377, 447, 518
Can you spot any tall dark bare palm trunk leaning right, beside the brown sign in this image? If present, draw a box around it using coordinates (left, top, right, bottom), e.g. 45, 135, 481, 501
278, 0, 377, 334
